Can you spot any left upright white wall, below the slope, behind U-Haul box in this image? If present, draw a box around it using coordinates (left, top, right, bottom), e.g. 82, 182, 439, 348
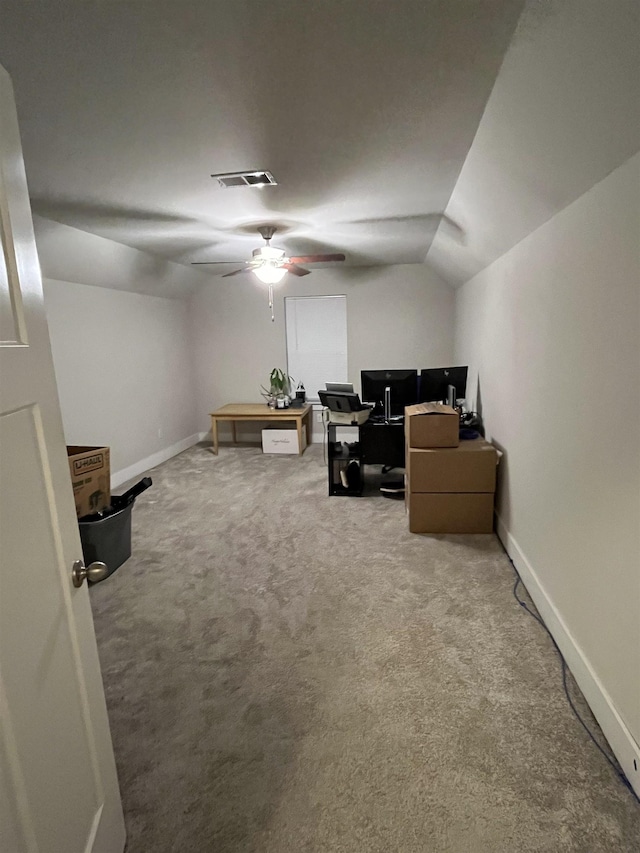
44, 279, 196, 488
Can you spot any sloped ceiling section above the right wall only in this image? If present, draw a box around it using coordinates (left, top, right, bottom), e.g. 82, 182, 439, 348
427, 0, 640, 284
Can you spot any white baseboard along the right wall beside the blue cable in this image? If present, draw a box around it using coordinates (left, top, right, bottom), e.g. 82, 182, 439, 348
496, 513, 640, 797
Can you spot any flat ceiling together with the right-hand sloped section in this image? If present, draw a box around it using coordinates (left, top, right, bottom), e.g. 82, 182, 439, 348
0, 0, 639, 284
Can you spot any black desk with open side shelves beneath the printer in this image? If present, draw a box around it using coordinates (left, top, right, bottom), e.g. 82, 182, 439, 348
328, 419, 405, 497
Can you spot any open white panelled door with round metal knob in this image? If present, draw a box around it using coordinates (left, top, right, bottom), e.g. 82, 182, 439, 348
0, 67, 125, 853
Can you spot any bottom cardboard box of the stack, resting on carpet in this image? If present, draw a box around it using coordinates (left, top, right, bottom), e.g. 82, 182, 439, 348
406, 492, 494, 533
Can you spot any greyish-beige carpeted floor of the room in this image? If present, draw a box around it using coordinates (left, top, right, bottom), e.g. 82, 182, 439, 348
91, 445, 640, 853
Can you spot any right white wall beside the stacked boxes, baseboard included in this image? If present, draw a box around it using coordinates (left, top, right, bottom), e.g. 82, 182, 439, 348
456, 155, 640, 790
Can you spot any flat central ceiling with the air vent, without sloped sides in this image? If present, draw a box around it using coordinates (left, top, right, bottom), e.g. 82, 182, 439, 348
0, 0, 523, 274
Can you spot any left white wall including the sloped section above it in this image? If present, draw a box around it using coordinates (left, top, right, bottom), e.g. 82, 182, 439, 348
34, 216, 210, 488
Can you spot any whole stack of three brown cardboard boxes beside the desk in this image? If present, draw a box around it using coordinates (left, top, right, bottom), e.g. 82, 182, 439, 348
405, 403, 497, 533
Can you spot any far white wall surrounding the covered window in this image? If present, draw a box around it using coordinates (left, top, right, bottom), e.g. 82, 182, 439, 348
190, 264, 455, 439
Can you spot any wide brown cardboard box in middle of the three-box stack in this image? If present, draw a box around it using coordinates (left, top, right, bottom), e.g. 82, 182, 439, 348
406, 438, 498, 492
